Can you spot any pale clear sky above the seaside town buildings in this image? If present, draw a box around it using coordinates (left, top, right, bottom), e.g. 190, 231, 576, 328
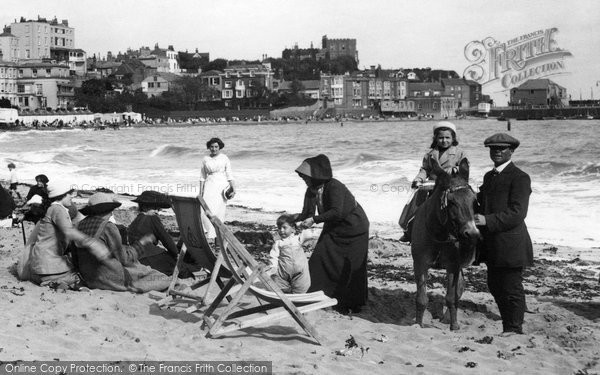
0, 0, 600, 104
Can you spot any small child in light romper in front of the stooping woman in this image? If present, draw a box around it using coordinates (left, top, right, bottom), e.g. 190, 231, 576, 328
269, 215, 310, 294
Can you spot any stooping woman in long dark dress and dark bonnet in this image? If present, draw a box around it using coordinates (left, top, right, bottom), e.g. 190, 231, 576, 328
296, 154, 369, 312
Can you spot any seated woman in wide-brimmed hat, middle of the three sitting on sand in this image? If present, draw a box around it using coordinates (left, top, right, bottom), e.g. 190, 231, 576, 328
76, 193, 170, 293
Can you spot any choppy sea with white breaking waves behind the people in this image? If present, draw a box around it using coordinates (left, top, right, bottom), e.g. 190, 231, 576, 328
0, 119, 600, 248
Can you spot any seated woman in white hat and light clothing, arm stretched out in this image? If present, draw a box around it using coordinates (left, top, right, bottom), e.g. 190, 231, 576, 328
27, 183, 108, 290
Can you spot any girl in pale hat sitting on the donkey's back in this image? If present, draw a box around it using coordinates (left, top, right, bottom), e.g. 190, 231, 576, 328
398, 121, 469, 242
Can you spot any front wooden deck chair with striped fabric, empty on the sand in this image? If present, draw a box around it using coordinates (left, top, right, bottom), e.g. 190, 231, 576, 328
199, 198, 337, 345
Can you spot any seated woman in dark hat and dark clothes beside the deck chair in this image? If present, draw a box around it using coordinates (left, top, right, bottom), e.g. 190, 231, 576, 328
127, 190, 191, 279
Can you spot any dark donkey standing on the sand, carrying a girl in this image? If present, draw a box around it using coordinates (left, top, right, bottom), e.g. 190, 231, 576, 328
411, 173, 481, 330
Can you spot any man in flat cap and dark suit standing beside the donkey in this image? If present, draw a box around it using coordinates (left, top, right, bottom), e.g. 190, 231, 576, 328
475, 133, 533, 334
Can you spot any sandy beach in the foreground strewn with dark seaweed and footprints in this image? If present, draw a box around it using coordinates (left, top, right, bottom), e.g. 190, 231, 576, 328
0, 187, 600, 374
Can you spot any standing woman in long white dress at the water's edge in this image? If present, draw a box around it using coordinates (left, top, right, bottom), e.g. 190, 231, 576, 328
200, 138, 235, 240
